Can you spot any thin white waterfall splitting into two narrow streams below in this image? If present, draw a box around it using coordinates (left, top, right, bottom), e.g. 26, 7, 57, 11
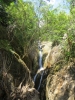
34, 41, 44, 90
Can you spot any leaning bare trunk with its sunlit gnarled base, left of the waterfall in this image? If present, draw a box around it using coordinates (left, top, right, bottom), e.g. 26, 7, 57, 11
10, 50, 39, 100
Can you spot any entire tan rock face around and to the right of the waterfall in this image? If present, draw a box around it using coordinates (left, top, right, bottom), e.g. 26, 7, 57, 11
27, 42, 75, 100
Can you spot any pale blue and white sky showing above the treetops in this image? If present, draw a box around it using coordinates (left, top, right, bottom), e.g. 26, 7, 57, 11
24, 0, 69, 13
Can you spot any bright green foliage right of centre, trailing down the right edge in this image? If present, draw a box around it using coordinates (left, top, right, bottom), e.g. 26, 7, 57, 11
40, 0, 75, 61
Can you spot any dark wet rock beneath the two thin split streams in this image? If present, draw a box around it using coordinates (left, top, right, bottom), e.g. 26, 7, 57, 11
35, 68, 50, 100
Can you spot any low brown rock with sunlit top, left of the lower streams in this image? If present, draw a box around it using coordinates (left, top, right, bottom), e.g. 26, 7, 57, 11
10, 86, 40, 100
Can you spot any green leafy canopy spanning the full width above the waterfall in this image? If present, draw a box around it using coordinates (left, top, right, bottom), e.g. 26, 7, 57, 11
0, 0, 75, 59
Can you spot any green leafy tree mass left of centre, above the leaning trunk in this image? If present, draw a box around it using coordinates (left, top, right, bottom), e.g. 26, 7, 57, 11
3, 0, 38, 54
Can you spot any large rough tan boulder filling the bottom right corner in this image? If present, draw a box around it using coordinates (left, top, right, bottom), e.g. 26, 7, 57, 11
46, 63, 75, 100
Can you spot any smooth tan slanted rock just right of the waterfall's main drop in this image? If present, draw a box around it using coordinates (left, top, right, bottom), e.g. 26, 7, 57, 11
44, 45, 62, 68
